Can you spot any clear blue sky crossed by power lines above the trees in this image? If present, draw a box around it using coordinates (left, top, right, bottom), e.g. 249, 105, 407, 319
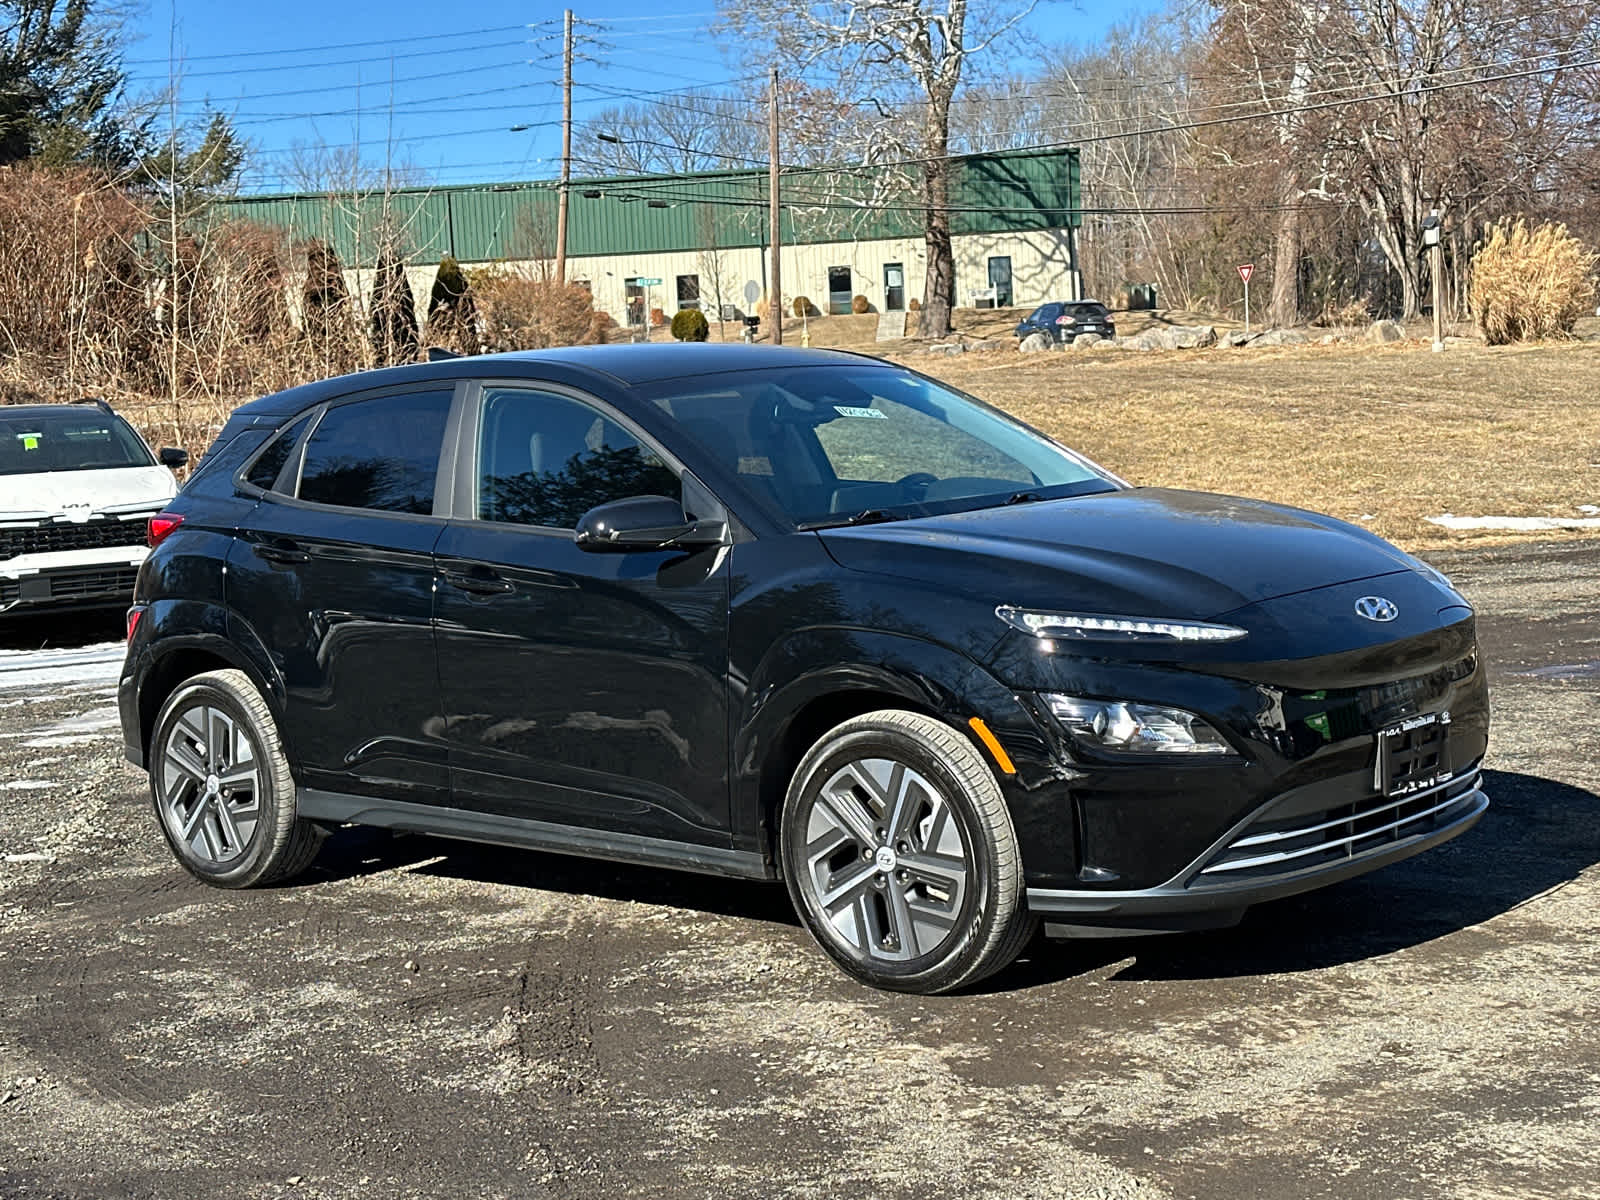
116, 0, 1157, 190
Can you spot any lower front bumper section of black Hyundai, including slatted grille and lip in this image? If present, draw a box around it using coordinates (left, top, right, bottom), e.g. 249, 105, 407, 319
1027, 765, 1490, 936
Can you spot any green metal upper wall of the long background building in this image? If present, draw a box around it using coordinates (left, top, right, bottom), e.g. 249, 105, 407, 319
218, 149, 1082, 266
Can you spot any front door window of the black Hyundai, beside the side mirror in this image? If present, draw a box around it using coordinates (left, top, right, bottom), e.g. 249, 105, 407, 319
478, 387, 680, 530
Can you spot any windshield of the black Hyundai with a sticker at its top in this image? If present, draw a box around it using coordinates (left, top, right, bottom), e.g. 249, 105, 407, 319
646, 363, 1118, 528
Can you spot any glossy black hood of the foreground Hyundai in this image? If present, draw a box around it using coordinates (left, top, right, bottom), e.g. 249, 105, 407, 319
821, 488, 1414, 621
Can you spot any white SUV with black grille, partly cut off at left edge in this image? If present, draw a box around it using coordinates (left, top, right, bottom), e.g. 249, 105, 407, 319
0, 400, 189, 619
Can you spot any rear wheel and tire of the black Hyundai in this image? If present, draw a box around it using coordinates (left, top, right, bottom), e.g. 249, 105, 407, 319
149, 670, 325, 888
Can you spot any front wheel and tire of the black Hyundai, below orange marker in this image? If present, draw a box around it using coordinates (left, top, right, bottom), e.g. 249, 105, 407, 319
779, 709, 1038, 995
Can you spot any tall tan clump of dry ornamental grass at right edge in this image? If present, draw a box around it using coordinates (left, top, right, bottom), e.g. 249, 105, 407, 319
1470, 219, 1600, 346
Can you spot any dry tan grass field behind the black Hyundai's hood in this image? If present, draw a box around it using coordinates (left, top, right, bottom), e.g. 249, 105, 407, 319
906, 331, 1600, 549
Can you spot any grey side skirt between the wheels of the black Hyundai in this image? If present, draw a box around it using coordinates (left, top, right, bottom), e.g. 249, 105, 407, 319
296, 787, 776, 880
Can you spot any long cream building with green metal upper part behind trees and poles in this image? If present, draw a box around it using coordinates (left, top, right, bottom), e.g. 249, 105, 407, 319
219, 149, 1082, 329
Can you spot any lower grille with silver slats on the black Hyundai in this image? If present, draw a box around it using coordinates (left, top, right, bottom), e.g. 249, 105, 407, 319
1189, 766, 1480, 888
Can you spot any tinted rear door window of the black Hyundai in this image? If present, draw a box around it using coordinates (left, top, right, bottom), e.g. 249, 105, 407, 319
299, 392, 451, 515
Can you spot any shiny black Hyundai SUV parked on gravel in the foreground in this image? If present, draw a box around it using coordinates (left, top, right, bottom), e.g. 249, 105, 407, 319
120, 346, 1488, 992
